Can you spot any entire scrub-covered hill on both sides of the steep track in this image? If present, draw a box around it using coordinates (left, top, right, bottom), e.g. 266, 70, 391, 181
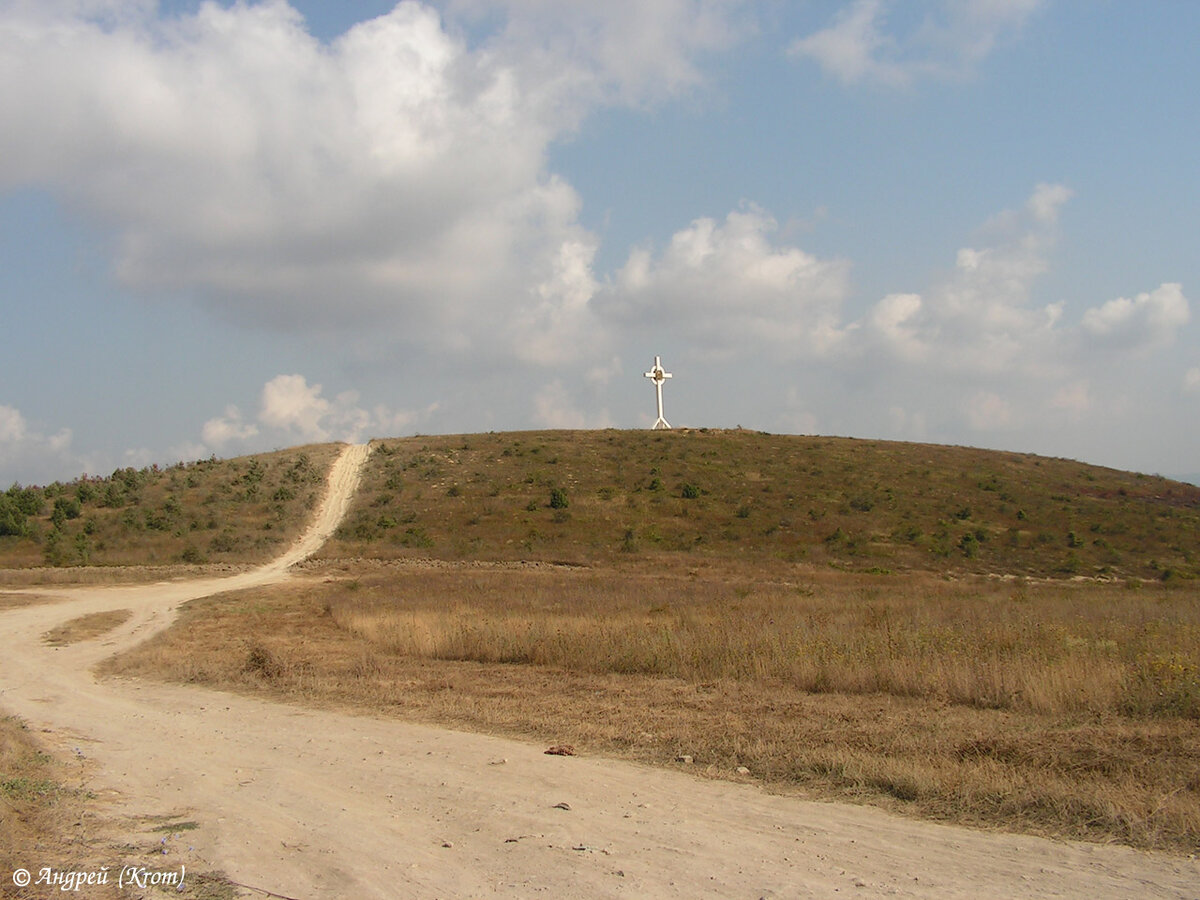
0, 428, 1200, 581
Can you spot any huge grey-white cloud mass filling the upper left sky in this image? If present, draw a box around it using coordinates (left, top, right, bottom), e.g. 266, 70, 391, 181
0, 0, 739, 362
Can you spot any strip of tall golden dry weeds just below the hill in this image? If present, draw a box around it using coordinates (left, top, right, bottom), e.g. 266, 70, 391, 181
329, 572, 1200, 718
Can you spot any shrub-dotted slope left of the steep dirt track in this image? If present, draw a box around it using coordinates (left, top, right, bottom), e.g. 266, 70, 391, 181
0, 444, 338, 568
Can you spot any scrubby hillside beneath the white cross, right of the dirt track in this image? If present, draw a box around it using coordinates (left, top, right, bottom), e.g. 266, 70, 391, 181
324, 430, 1200, 581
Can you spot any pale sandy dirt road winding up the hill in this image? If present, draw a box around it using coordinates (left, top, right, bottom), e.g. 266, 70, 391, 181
0, 446, 1200, 900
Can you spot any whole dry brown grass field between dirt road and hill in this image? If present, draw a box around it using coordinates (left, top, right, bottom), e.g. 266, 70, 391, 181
100, 566, 1200, 851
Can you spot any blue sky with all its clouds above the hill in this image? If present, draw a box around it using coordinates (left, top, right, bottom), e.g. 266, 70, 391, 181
0, 0, 1200, 486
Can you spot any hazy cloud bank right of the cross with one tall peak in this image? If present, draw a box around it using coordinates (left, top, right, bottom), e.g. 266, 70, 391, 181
839, 184, 1200, 451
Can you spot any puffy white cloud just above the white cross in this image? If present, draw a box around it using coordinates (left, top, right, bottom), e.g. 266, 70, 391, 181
595, 206, 848, 356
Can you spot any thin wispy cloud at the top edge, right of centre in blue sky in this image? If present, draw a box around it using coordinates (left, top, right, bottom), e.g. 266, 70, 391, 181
790, 0, 1042, 86
